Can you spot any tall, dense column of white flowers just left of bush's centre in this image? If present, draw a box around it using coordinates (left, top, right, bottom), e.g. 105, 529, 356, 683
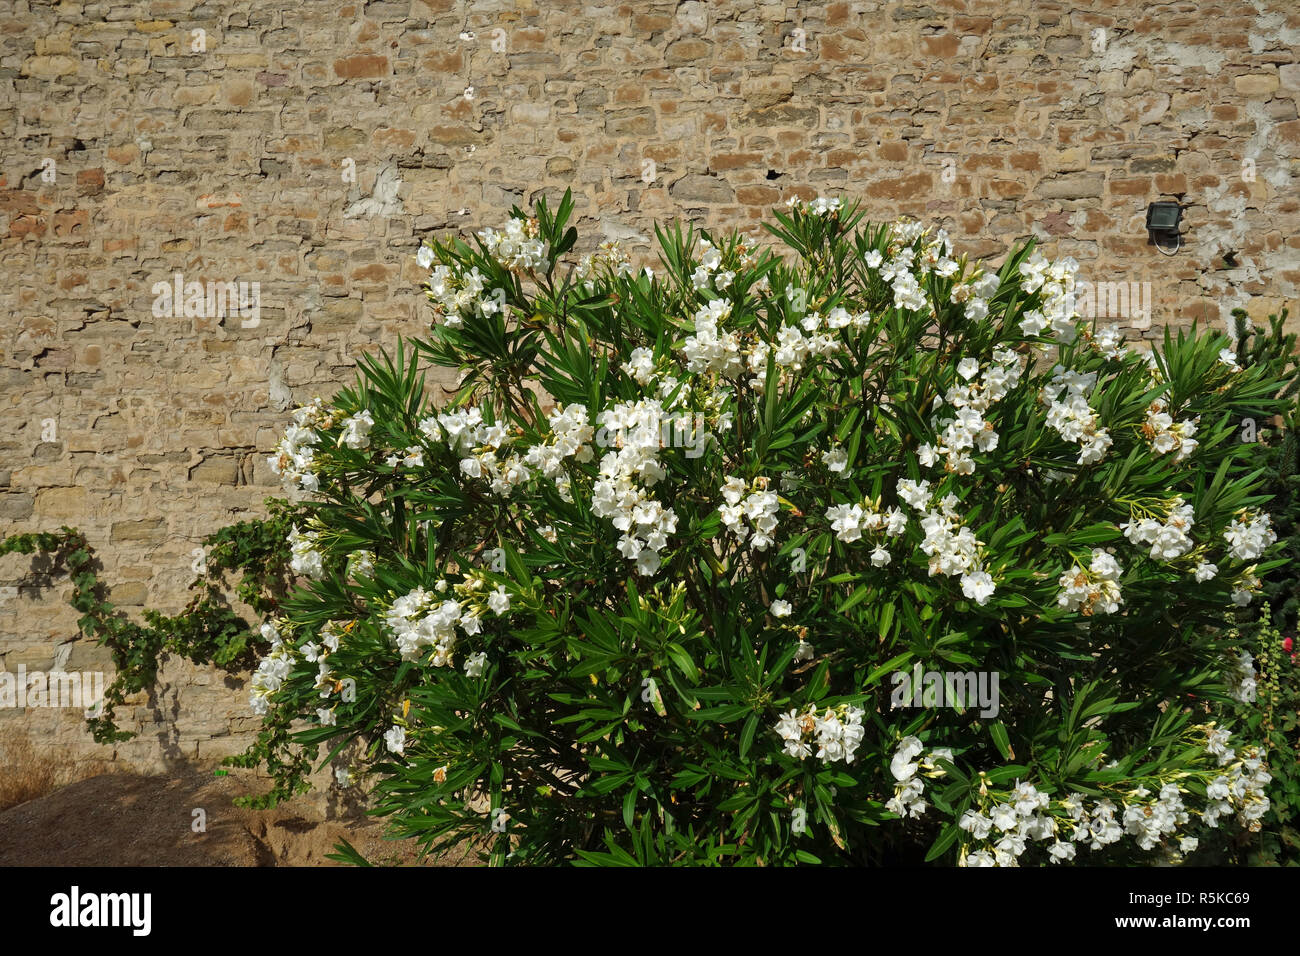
592, 399, 677, 575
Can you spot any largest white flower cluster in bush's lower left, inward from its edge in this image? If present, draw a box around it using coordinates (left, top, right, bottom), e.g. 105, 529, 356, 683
384, 576, 510, 667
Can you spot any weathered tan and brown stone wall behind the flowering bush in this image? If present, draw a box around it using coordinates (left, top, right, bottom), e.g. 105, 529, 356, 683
0, 0, 1300, 765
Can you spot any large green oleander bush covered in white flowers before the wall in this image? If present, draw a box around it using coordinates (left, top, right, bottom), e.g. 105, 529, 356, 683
241, 195, 1281, 865
